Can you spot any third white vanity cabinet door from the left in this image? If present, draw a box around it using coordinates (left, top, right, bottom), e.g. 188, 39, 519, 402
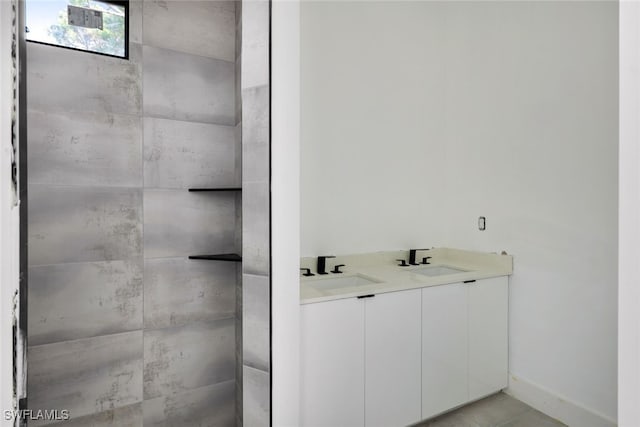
422, 283, 468, 418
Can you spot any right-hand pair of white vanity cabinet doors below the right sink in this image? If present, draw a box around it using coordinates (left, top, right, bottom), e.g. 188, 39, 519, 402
422, 277, 508, 418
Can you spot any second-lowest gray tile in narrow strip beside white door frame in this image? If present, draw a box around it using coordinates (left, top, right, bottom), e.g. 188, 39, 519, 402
242, 274, 270, 372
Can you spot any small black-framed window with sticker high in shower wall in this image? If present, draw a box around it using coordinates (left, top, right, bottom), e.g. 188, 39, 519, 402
25, 0, 129, 58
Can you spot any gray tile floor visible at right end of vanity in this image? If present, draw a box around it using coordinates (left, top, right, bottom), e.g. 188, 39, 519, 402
413, 393, 566, 427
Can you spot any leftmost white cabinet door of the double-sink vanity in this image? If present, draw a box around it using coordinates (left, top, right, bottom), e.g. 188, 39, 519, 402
300, 298, 364, 427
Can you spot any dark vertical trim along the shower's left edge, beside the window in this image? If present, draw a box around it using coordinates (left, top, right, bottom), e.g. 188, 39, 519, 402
17, 0, 29, 425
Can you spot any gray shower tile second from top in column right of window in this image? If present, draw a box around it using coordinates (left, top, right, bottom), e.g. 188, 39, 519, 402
143, 46, 236, 126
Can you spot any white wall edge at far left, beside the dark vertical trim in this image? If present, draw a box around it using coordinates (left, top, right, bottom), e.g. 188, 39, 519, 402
0, 1, 19, 426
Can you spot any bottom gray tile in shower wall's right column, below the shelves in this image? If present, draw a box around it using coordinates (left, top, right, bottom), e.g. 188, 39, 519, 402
143, 380, 235, 427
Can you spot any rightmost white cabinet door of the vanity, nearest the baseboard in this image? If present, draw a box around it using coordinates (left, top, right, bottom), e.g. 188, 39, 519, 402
468, 277, 509, 400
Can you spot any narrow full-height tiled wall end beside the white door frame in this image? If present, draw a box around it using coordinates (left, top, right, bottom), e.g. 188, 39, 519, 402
240, 0, 271, 427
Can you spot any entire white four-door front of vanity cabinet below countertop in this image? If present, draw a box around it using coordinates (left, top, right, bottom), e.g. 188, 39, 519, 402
300, 276, 508, 427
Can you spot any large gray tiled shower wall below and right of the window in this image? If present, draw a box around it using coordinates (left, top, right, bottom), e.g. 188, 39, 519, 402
28, 1, 241, 427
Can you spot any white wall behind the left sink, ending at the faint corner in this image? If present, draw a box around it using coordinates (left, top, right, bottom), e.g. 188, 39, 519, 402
300, 2, 445, 256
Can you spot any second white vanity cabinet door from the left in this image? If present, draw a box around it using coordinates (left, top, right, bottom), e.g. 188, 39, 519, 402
365, 289, 421, 427
